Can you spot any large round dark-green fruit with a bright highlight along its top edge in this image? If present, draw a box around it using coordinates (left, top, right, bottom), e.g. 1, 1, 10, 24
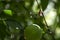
24, 25, 42, 40
